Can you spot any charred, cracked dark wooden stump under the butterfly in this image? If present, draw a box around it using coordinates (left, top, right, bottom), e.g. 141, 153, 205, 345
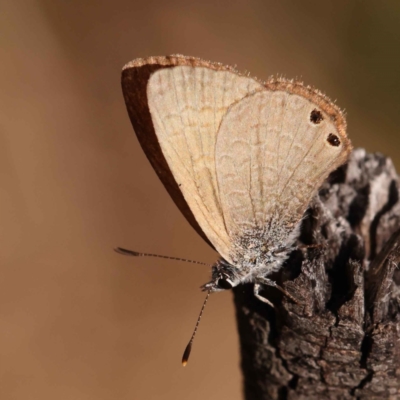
234, 149, 400, 400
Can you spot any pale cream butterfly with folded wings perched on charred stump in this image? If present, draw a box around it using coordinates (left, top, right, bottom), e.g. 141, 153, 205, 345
120, 55, 352, 364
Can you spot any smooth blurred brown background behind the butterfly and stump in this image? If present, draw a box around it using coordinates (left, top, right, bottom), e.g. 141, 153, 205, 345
0, 0, 400, 400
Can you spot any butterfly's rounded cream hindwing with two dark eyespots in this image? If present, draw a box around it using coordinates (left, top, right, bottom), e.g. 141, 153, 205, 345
216, 90, 351, 241
